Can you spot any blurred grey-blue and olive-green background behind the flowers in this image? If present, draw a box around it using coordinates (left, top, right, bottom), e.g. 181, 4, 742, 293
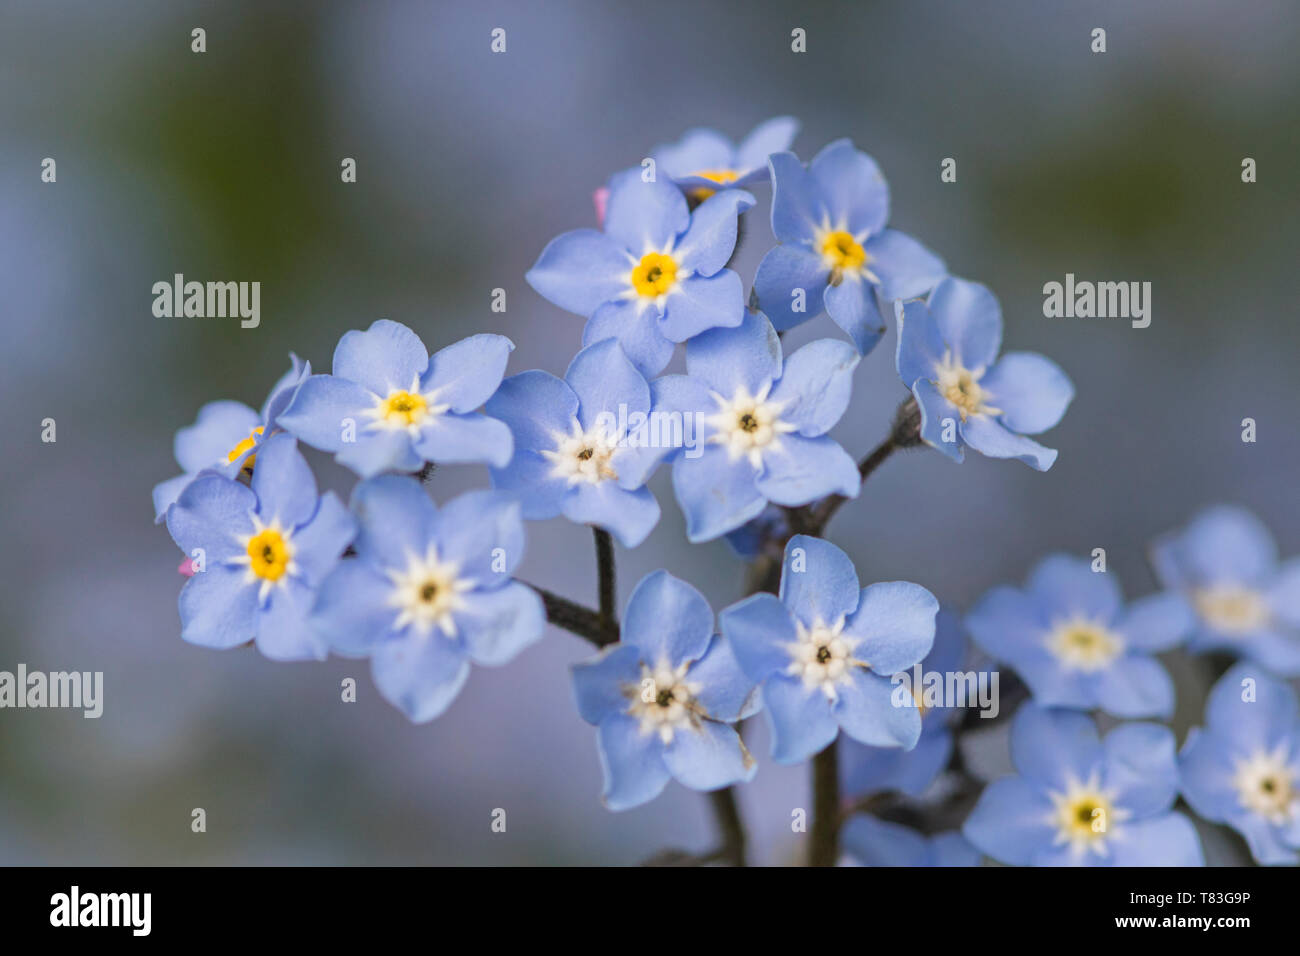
0, 0, 1300, 864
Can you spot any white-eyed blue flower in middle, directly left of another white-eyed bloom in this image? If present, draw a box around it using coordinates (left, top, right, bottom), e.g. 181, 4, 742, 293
485, 338, 681, 548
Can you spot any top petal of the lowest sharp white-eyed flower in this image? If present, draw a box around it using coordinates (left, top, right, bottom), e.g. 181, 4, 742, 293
623, 571, 714, 667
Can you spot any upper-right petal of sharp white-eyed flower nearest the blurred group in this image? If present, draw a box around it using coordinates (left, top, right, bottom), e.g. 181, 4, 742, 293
845, 581, 939, 678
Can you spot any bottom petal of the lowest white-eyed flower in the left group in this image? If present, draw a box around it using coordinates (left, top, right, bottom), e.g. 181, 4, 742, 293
371, 631, 469, 723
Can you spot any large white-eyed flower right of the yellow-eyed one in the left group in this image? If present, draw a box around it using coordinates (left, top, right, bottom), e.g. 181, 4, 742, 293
315, 475, 546, 723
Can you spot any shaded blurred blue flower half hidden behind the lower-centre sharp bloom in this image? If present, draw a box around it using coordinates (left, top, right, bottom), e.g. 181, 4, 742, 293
839, 607, 976, 797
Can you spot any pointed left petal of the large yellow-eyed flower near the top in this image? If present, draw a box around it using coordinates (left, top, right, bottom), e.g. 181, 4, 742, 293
524, 229, 636, 316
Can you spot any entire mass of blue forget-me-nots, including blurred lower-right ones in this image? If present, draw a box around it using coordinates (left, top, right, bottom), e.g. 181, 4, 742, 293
153, 117, 1300, 865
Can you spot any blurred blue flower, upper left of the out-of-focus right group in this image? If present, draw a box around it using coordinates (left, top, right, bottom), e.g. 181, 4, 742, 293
966, 554, 1192, 717
